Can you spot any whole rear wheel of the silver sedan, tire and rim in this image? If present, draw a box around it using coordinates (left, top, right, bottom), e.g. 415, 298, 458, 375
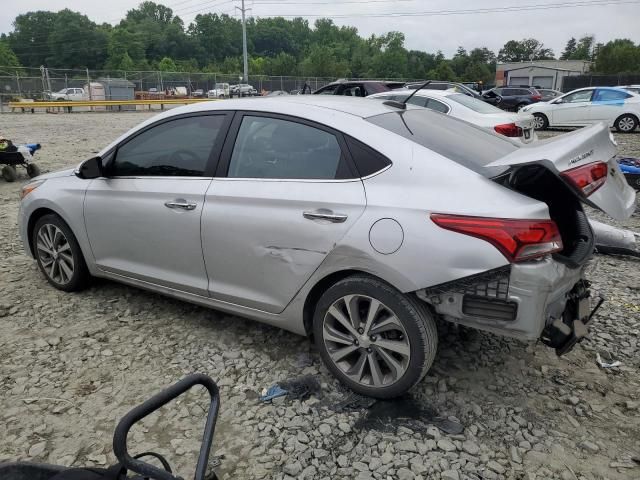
313, 275, 438, 398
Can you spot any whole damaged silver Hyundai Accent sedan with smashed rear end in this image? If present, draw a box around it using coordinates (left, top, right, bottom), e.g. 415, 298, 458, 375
19, 95, 635, 398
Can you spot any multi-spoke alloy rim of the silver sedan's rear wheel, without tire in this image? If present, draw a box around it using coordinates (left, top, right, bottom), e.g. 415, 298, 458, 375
322, 295, 411, 387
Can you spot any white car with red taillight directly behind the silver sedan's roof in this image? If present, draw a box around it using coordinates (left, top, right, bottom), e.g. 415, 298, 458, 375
367, 89, 537, 143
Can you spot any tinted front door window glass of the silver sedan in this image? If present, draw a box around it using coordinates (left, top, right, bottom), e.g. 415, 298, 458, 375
109, 115, 224, 177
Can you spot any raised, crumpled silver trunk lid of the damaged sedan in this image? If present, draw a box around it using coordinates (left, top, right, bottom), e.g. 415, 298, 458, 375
486, 123, 636, 220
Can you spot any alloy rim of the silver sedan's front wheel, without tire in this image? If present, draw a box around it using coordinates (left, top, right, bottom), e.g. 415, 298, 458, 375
36, 223, 75, 285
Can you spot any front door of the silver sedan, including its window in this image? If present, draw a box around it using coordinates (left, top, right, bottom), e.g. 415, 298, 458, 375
84, 115, 225, 295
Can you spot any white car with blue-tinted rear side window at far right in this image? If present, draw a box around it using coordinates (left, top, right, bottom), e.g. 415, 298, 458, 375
520, 87, 640, 133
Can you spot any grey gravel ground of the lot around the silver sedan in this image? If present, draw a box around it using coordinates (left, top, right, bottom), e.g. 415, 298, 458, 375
0, 113, 640, 480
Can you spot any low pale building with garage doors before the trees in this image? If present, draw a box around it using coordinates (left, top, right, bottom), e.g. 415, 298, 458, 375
496, 60, 591, 90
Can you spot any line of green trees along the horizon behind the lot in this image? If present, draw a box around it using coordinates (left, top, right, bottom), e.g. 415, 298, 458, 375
0, 1, 640, 84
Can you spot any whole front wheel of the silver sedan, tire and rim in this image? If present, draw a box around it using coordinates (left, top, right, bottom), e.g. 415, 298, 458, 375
32, 214, 89, 292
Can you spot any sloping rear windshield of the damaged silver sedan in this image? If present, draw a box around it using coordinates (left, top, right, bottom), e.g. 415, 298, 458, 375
366, 109, 519, 177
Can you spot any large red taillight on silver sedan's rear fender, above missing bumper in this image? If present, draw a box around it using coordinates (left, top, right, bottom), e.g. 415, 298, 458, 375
431, 213, 562, 262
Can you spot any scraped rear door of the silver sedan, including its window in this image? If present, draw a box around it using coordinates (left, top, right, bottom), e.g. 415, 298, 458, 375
202, 113, 366, 313
